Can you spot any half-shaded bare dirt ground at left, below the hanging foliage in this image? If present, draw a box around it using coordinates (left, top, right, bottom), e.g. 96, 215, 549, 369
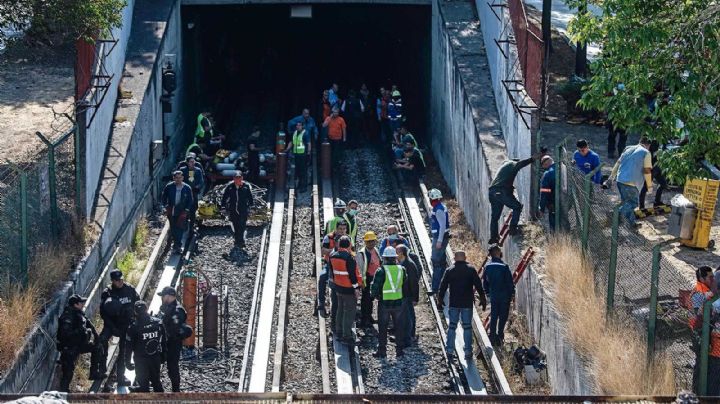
0, 43, 75, 162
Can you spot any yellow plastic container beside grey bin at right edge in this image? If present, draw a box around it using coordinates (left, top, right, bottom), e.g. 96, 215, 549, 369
680, 178, 720, 248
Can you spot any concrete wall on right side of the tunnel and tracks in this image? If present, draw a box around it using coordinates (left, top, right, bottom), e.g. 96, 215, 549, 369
431, 1, 593, 395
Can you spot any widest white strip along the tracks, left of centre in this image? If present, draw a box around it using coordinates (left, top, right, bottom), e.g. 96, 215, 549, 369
248, 193, 285, 393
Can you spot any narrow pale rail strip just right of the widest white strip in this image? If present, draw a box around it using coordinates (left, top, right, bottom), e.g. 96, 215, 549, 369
272, 191, 295, 393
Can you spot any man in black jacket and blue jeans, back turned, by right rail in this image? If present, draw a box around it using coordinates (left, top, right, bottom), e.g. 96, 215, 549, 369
438, 251, 487, 361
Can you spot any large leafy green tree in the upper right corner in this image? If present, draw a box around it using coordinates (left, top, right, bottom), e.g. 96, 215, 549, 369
568, 0, 720, 183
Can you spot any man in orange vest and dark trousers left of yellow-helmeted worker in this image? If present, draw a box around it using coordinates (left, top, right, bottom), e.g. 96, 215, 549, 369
328, 236, 363, 346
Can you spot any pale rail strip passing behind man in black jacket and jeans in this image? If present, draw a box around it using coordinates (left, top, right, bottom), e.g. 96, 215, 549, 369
405, 197, 487, 395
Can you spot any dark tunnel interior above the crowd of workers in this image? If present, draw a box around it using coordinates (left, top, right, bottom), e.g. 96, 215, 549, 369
183, 4, 431, 146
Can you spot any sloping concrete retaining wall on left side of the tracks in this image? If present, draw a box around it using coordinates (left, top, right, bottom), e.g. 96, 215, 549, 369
0, 0, 184, 393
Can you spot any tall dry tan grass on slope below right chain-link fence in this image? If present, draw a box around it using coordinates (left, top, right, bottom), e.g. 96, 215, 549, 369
545, 236, 675, 395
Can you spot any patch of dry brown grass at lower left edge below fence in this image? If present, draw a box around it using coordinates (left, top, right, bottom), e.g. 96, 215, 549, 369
0, 286, 40, 369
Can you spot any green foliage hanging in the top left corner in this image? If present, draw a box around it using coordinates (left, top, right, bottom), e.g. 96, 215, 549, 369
0, 0, 127, 45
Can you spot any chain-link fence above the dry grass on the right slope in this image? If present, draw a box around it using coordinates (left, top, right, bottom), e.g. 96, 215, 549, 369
553, 145, 695, 388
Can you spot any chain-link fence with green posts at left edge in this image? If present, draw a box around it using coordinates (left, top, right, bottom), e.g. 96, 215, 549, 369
0, 118, 77, 293
